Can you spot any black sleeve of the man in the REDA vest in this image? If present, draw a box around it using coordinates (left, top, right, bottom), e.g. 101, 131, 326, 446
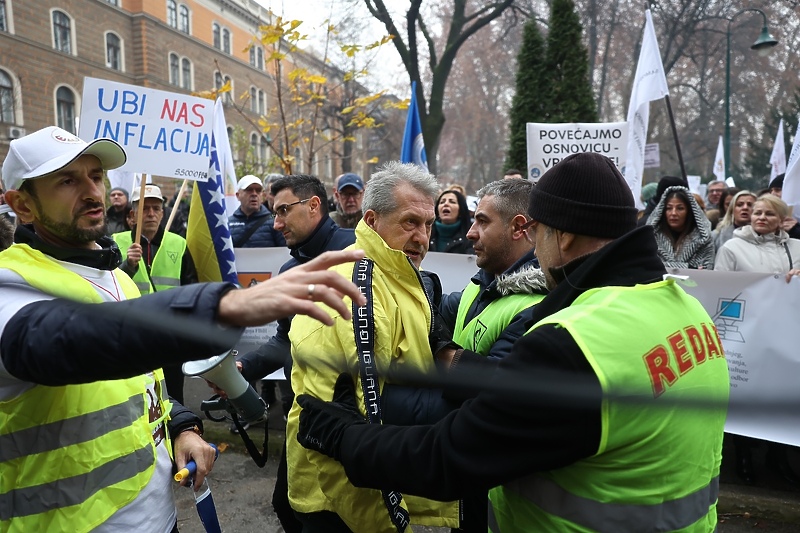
341, 326, 601, 501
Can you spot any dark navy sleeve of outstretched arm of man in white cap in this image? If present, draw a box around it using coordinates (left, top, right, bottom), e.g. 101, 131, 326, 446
0, 283, 241, 386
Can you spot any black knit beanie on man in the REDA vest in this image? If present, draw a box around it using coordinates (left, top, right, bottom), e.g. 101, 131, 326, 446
528, 153, 637, 239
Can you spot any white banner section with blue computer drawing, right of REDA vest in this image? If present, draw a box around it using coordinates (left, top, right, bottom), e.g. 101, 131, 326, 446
678, 270, 800, 446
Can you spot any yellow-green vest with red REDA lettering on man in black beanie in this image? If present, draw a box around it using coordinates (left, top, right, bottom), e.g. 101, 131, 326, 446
490, 281, 729, 533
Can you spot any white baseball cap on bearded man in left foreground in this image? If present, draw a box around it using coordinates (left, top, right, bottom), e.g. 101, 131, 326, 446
3, 126, 127, 191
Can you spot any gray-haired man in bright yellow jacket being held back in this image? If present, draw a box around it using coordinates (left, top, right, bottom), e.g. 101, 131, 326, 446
288, 162, 459, 533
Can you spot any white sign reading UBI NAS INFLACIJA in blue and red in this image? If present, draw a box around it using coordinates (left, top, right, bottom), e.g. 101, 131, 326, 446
78, 78, 214, 181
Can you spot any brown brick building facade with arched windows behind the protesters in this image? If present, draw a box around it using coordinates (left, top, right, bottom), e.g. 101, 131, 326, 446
0, 0, 385, 193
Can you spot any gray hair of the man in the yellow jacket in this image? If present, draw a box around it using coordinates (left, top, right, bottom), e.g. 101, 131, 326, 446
361, 161, 439, 215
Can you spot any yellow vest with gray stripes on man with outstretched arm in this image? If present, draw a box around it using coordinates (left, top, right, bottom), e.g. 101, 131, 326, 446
0, 244, 172, 533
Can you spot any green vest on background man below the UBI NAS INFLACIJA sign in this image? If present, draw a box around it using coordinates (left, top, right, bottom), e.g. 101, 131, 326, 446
112, 231, 186, 294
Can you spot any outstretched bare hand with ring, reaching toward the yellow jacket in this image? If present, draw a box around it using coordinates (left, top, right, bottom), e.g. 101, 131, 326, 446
217, 250, 365, 327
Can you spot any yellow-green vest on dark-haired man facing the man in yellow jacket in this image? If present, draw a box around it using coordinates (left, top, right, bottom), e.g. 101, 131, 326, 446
453, 281, 544, 355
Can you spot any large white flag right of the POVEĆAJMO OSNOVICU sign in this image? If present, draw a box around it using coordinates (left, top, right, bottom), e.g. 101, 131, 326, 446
623, 9, 669, 209
